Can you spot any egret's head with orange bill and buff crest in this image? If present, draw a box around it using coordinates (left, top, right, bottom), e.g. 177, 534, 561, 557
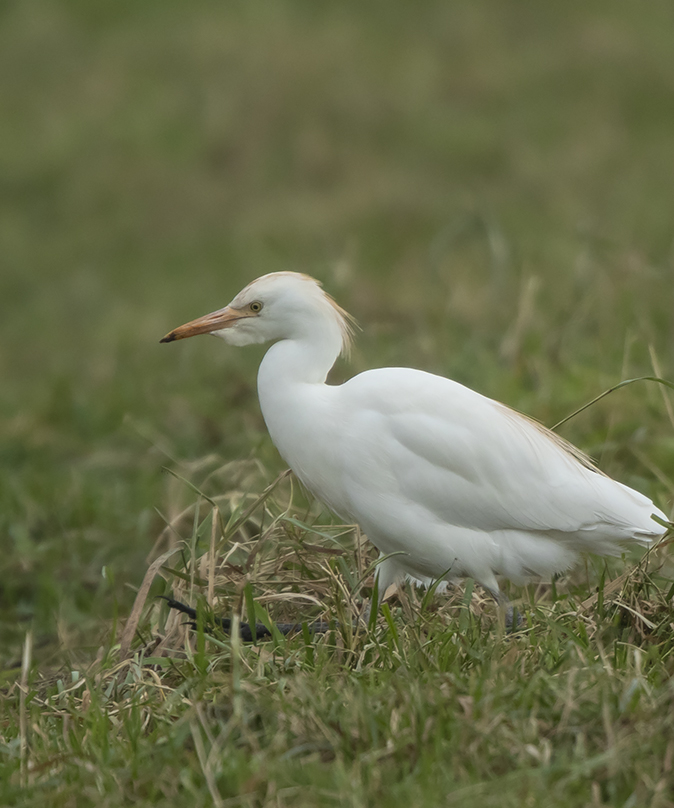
161, 272, 354, 348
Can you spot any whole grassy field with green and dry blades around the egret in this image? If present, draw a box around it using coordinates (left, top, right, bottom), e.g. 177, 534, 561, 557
0, 0, 674, 808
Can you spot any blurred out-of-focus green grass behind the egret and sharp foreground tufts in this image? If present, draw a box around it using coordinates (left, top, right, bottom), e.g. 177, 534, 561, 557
0, 0, 674, 664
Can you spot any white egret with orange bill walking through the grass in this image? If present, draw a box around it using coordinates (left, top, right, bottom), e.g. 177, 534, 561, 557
161, 272, 666, 599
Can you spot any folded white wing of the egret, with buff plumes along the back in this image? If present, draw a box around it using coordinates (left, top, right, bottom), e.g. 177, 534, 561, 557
336, 368, 661, 540
